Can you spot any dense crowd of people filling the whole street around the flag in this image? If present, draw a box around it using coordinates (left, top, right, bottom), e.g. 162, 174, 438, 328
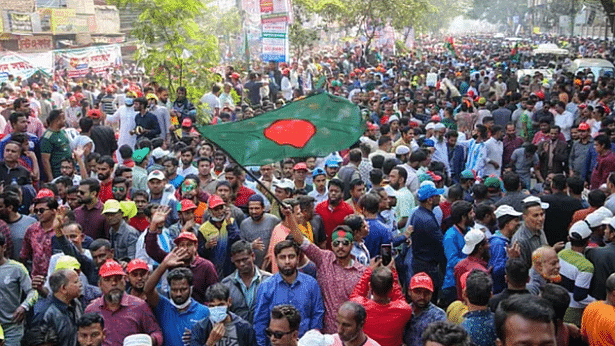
0, 33, 615, 346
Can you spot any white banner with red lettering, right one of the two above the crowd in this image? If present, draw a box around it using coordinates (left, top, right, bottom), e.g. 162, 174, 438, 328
54, 45, 122, 78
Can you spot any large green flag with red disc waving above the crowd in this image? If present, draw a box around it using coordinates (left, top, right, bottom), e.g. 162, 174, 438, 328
197, 93, 365, 166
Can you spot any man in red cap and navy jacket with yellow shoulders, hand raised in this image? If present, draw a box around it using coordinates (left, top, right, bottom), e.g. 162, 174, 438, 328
197, 195, 239, 277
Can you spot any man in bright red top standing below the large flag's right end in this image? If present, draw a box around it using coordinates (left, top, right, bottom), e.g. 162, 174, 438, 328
315, 178, 354, 249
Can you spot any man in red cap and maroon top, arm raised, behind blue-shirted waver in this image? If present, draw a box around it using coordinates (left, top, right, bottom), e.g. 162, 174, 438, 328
145, 206, 218, 304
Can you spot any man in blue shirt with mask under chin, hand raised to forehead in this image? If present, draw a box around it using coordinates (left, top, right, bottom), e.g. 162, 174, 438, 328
144, 246, 209, 346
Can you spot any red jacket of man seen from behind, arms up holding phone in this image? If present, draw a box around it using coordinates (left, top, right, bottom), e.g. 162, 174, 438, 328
350, 268, 412, 346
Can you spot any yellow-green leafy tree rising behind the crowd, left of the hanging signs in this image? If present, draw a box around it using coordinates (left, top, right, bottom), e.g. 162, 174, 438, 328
113, 0, 220, 104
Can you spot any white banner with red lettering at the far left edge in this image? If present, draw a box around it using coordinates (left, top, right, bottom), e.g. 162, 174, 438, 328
0, 51, 53, 82
